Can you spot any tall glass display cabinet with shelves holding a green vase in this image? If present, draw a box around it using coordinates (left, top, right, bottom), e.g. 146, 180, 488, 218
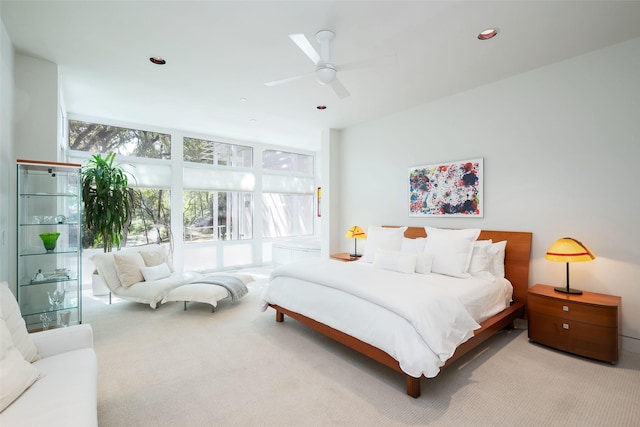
17, 160, 82, 331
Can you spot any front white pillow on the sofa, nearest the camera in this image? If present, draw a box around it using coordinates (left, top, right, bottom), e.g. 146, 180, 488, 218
0, 320, 40, 412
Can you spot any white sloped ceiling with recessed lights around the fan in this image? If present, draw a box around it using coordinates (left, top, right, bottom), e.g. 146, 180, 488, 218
0, 0, 640, 150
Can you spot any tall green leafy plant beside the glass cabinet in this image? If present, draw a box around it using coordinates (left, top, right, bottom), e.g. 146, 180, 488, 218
81, 153, 134, 295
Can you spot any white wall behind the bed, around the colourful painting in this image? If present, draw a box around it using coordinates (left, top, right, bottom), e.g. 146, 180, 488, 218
332, 39, 640, 352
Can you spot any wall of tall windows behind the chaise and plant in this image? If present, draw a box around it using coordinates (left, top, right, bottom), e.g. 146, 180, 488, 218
68, 116, 317, 276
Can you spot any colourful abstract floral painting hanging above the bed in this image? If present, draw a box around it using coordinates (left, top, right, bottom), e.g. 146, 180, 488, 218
408, 157, 484, 218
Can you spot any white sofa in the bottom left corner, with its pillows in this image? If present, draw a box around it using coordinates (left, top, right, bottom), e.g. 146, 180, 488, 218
0, 282, 98, 427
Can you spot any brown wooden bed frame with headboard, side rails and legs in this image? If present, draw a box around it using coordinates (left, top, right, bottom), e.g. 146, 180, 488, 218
269, 227, 532, 397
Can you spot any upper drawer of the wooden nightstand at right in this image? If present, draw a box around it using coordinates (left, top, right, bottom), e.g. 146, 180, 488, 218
527, 294, 618, 328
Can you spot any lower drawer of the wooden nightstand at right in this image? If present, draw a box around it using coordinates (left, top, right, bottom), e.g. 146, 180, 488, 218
529, 312, 618, 362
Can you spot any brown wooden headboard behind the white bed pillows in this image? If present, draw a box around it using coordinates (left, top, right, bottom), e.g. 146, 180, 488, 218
385, 226, 532, 305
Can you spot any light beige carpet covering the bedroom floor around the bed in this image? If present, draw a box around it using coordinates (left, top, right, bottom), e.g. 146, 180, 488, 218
84, 280, 640, 427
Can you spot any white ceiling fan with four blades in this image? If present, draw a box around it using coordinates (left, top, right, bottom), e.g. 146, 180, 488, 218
265, 30, 390, 99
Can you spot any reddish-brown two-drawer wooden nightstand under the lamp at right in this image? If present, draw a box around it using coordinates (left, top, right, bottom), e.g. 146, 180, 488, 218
527, 285, 621, 363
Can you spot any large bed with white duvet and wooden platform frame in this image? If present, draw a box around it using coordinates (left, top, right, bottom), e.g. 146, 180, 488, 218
262, 226, 532, 397
